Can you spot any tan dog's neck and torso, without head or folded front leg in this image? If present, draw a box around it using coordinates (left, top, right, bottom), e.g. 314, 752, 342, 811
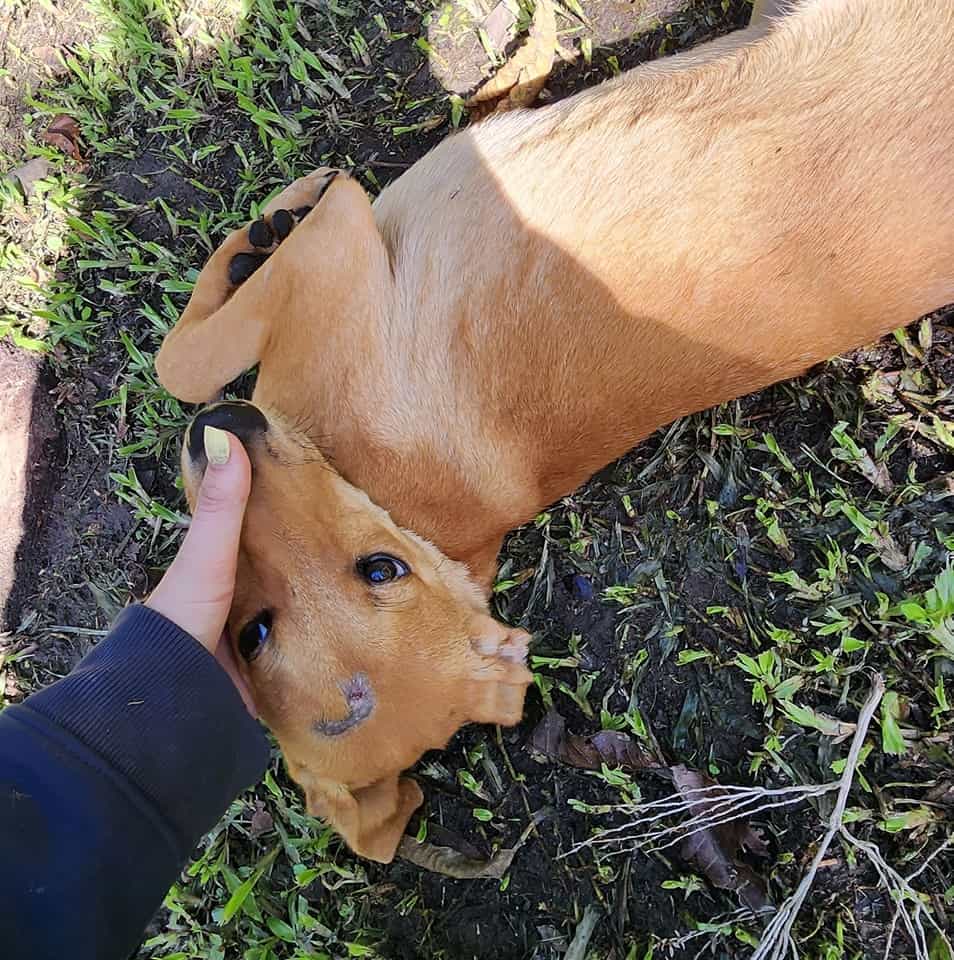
255, 2, 954, 581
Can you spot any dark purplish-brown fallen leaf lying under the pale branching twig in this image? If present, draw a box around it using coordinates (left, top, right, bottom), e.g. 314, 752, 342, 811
671, 764, 771, 913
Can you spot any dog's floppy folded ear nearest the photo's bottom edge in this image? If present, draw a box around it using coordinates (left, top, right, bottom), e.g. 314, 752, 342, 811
302, 776, 424, 863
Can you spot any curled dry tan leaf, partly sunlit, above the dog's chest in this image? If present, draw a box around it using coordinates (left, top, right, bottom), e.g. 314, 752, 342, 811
466, 0, 557, 121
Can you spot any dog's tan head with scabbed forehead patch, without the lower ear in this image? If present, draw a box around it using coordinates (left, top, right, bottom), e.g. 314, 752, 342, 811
182, 401, 530, 813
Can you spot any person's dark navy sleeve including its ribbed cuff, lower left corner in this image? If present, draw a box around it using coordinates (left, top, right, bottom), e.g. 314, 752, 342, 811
0, 606, 268, 960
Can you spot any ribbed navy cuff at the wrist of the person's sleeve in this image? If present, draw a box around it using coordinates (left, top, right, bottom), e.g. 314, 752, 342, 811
23, 605, 269, 850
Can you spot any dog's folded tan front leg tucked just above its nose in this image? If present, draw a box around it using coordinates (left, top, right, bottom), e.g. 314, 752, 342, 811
156, 176, 390, 403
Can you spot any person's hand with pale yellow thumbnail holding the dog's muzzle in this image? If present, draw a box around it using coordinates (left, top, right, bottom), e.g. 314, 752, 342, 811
146, 427, 256, 716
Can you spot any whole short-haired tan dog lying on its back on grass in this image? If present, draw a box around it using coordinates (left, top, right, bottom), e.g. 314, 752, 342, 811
157, 0, 954, 860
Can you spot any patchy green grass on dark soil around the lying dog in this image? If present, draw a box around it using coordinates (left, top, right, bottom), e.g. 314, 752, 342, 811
0, 0, 954, 960
